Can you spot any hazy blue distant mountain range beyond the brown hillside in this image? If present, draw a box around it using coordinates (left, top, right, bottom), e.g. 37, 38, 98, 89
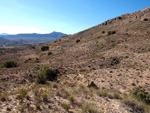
0, 31, 67, 47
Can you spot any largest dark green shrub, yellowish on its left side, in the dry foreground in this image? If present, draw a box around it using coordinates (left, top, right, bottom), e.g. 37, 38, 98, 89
36, 67, 57, 84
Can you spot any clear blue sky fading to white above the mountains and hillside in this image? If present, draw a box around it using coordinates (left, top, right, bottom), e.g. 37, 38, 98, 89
0, 0, 150, 34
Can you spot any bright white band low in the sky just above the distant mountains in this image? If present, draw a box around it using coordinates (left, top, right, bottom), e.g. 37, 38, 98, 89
0, 26, 52, 34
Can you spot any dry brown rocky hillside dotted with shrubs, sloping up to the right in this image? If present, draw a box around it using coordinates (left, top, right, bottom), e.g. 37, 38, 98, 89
0, 8, 150, 113
